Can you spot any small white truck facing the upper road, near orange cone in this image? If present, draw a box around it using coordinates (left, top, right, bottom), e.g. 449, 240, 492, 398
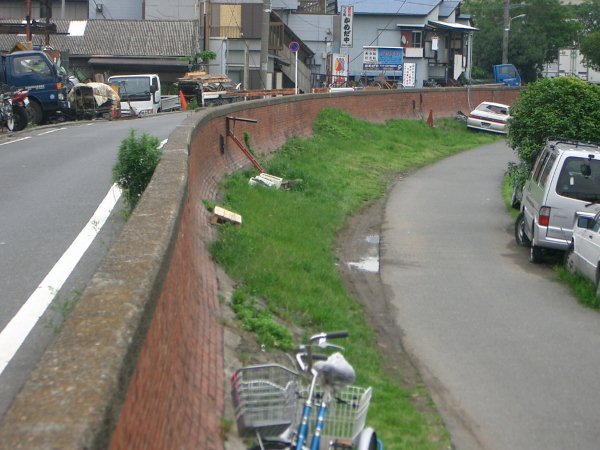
107, 73, 181, 116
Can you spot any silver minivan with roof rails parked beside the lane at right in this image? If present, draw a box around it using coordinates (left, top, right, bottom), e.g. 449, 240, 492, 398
515, 139, 600, 262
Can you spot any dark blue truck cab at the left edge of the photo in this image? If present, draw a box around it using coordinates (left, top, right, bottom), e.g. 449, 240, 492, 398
0, 50, 69, 125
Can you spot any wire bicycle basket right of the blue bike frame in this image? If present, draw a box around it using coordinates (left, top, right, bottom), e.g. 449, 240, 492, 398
296, 386, 373, 443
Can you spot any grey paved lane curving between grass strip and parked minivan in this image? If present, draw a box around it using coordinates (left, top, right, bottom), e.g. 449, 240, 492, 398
381, 142, 600, 450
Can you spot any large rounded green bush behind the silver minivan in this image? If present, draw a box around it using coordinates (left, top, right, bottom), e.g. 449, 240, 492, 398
508, 77, 600, 173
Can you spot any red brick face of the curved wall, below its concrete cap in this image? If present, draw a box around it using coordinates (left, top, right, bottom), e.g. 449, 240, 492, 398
106, 88, 519, 450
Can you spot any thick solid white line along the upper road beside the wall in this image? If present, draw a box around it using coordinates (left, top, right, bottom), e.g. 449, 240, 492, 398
0, 185, 121, 374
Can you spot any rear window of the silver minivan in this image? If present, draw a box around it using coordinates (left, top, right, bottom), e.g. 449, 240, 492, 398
556, 157, 600, 203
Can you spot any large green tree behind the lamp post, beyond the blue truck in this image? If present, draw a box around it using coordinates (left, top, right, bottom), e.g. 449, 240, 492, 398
462, 0, 580, 82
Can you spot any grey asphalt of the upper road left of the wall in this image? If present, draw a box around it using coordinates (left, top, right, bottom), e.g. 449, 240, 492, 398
0, 113, 188, 417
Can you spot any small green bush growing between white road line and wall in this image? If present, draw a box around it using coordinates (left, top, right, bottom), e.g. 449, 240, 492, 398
112, 130, 162, 211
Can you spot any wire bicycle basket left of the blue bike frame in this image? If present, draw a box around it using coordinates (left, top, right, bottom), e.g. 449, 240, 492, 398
231, 364, 298, 436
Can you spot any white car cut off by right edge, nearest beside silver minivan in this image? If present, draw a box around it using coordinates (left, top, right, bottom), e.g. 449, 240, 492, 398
564, 211, 600, 289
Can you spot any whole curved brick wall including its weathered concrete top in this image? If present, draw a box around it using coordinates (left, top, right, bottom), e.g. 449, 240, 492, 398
0, 87, 519, 450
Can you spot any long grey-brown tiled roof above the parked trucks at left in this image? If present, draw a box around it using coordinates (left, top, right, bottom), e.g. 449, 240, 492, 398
0, 20, 198, 57
